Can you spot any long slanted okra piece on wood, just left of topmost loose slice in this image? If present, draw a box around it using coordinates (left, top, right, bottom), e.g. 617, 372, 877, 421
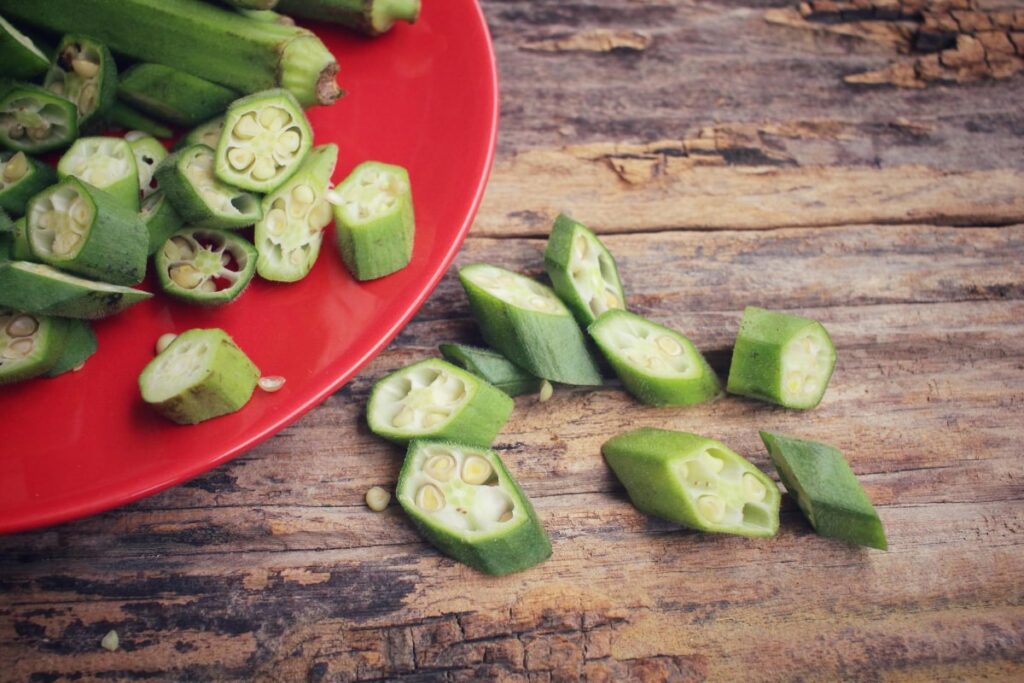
459, 263, 601, 385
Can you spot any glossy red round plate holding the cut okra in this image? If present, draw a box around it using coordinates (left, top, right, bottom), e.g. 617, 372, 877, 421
0, 0, 498, 532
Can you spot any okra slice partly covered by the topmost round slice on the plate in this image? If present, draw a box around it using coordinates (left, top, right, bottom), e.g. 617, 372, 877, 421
157, 144, 263, 229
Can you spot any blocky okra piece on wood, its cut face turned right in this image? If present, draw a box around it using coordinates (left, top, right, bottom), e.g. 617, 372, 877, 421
725, 306, 836, 410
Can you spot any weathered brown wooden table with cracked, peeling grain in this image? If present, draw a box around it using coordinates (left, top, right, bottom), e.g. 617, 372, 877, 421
0, 0, 1024, 682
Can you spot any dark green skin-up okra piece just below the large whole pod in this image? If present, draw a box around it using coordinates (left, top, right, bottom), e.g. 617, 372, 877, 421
118, 63, 239, 126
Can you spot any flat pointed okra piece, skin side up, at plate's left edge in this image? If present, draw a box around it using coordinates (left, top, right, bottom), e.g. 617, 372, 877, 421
0, 260, 153, 319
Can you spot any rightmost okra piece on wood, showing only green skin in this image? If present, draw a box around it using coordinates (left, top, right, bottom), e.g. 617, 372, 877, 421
761, 431, 889, 550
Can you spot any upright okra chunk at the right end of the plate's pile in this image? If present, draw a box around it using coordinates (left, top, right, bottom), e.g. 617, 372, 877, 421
333, 162, 416, 281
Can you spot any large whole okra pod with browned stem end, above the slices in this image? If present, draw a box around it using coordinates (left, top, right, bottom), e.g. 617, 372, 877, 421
3, 0, 341, 106
